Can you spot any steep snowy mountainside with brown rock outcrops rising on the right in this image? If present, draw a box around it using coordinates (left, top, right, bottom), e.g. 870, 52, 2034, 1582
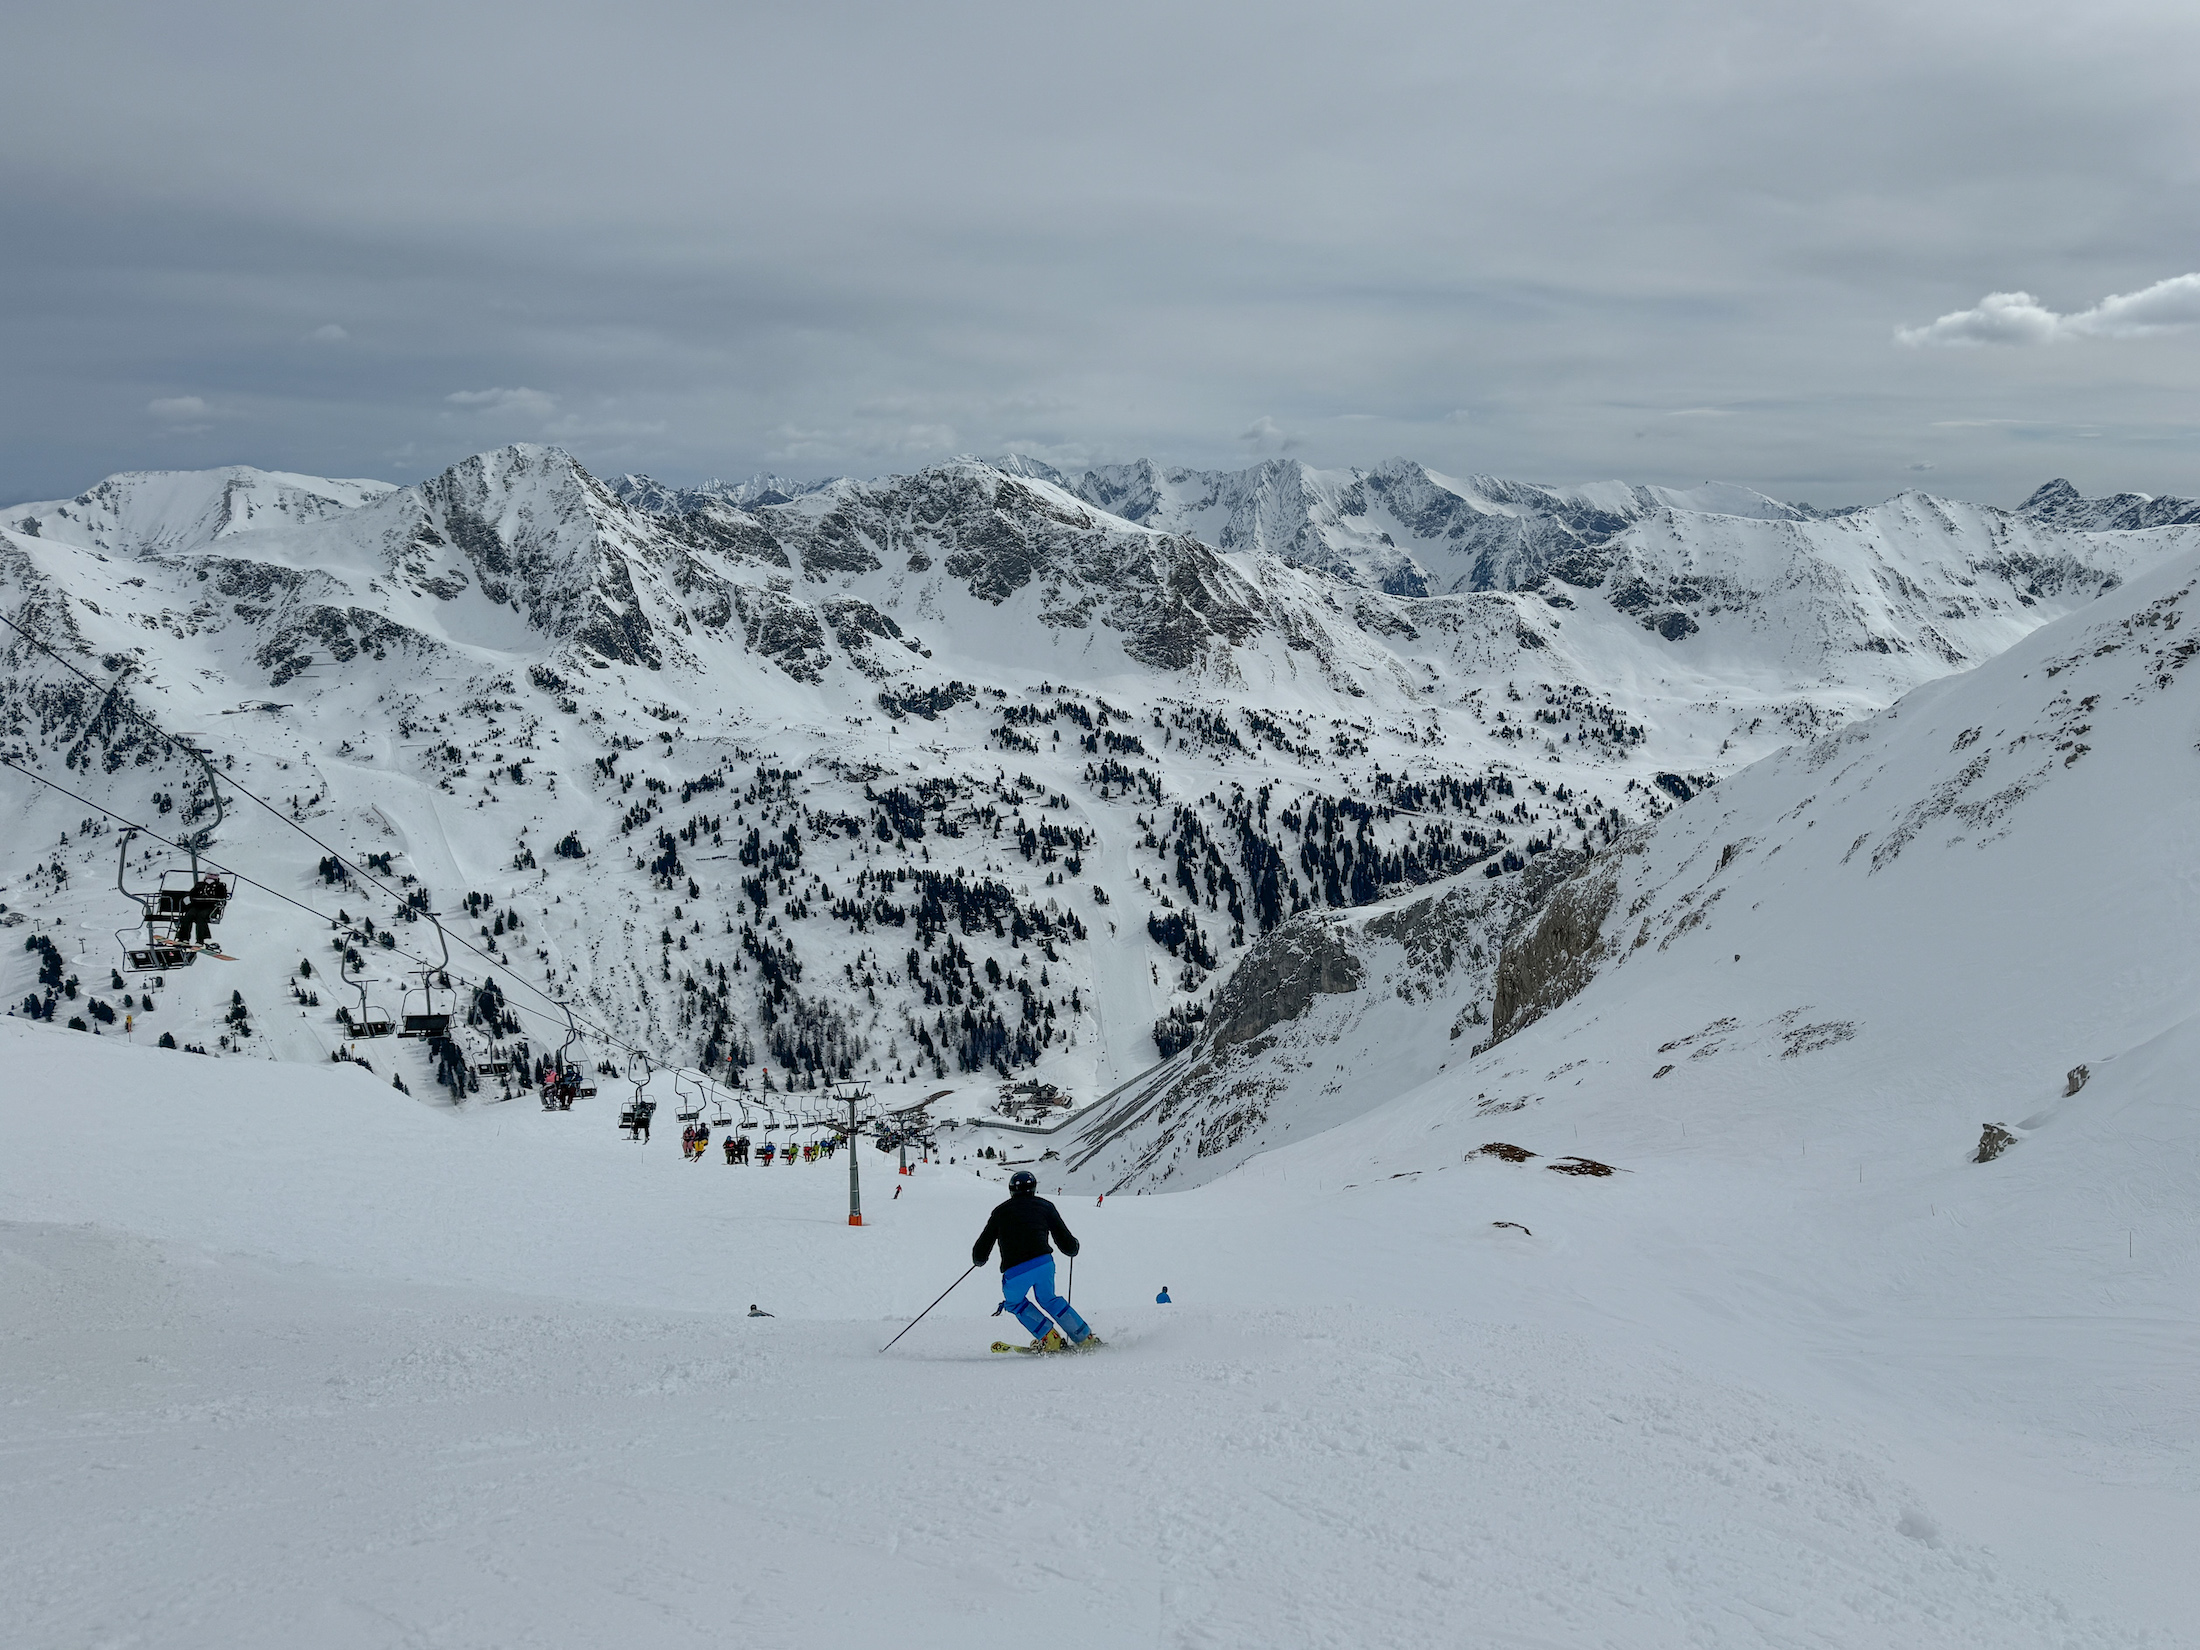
1065, 477, 2200, 1186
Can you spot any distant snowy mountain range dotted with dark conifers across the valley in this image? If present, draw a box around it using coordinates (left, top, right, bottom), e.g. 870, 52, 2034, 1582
0, 447, 2200, 1126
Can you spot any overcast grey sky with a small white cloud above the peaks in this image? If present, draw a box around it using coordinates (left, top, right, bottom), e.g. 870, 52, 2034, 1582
0, 0, 2200, 504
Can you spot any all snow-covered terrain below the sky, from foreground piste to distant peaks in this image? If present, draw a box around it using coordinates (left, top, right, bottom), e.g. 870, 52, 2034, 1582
0, 447, 2200, 1650
